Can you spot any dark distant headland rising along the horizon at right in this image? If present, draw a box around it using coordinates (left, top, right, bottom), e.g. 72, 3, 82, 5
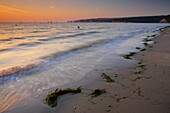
68, 15, 170, 23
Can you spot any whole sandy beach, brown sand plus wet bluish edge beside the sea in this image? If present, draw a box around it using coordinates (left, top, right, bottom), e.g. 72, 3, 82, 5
7, 28, 170, 113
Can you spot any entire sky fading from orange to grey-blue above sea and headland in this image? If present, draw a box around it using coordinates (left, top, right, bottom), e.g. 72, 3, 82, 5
0, 0, 170, 22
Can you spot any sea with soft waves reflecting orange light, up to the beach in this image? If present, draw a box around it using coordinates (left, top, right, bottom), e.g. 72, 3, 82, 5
0, 23, 166, 112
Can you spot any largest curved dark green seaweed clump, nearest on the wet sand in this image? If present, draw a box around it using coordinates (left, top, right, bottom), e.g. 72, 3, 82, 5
45, 87, 81, 108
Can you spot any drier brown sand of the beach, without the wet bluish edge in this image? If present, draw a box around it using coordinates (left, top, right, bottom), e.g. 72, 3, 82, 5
59, 27, 170, 113
